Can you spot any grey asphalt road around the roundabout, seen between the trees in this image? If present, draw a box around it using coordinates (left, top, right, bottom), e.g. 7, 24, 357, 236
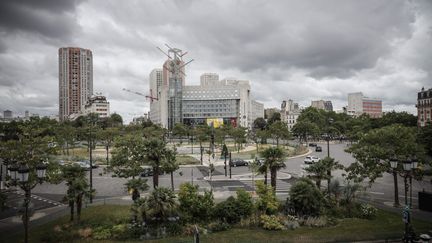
4, 143, 432, 215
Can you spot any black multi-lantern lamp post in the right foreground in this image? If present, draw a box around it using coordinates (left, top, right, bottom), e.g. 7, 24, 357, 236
390, 156, 418, 242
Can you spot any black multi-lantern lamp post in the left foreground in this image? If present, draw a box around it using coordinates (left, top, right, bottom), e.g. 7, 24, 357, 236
8, 161, 47, 243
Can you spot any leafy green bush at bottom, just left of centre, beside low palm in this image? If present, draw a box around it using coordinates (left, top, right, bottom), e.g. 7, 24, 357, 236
178, 183, 214, 223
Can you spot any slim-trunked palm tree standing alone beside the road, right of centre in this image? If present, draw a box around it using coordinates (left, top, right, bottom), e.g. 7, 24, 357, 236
261, 147, 286, 191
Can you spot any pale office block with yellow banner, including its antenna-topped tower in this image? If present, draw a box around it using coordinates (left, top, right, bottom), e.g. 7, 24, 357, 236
149, 49, 264, 129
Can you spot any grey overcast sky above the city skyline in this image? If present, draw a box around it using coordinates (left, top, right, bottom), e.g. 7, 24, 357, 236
0, 0, 432, 120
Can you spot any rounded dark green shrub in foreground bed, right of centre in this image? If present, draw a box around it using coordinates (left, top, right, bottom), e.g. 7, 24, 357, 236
287, 178, 324, 216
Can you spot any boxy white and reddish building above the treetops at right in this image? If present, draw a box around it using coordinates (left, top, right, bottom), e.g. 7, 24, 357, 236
347, 92, 382, 118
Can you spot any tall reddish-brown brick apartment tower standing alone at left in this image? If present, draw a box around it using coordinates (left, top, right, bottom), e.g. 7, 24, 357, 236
59, 47, 93, 121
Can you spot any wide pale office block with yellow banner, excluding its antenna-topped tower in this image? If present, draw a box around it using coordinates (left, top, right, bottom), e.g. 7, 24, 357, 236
150, 69, 264, 129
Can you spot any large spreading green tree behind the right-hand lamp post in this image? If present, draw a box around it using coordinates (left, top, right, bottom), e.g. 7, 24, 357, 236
346, 124, 422, 205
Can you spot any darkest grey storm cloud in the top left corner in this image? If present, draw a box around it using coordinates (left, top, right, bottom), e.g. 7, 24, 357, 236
0, 0, 82, 39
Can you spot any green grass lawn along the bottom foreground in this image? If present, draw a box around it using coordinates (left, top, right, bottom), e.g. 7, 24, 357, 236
6, 205, 432, 243
